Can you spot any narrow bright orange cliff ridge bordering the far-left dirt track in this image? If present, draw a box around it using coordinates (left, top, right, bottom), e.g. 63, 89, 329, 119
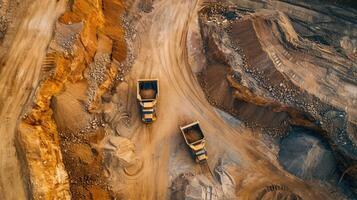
18, 54, 71, 199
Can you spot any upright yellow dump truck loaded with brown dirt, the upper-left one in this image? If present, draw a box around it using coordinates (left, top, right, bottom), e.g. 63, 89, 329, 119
137, 79, 159, 123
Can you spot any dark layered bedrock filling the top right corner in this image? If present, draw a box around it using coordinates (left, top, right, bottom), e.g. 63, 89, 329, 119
225, 0, 357, 58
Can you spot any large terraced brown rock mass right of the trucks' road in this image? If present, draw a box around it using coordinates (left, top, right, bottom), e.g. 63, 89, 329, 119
200, 1, 357, 195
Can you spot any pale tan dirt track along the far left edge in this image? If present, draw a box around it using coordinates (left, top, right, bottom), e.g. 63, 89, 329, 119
0, 0, 66, 200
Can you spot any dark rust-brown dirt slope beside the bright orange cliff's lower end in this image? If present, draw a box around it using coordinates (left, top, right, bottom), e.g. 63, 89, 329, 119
60, 130, 112, 200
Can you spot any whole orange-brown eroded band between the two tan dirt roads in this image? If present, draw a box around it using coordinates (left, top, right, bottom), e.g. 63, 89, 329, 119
18, 0, 130, 199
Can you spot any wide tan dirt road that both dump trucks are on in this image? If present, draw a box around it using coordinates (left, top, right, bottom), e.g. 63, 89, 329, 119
113, 0, 334, 199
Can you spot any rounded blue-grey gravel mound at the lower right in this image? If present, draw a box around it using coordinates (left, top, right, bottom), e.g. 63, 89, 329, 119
279, 128, 338, 180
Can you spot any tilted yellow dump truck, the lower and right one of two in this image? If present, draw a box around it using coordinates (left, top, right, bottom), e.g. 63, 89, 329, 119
180, 121, 208, 164
